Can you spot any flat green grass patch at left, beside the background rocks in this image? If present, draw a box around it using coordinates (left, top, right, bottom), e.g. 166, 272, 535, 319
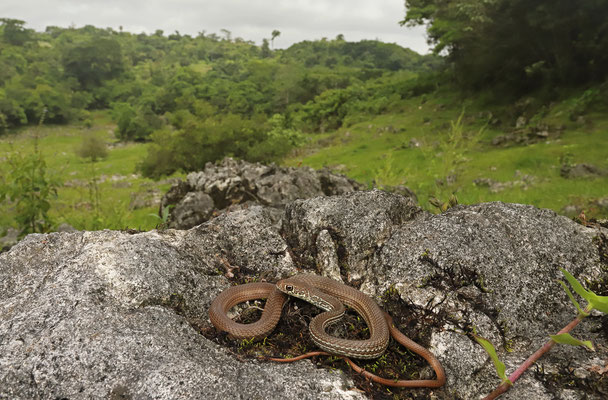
0, 112, 182, 230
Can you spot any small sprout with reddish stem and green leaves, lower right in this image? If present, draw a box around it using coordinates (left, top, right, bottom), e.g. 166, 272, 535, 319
480, 268, 608, 400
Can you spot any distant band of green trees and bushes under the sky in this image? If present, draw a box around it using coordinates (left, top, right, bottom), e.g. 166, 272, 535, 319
0, 19, 442, 176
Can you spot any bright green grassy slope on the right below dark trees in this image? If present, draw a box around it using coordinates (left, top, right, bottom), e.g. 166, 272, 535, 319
285, 86, 608, 218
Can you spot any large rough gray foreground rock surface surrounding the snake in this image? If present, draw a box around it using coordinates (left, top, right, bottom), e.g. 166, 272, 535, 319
0, 190, 608, 400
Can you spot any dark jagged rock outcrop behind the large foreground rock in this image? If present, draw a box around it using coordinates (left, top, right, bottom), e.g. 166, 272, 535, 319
160, 158, 364, 229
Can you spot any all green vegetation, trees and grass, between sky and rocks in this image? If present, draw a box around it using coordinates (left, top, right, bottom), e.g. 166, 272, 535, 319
0, 0, 608, 238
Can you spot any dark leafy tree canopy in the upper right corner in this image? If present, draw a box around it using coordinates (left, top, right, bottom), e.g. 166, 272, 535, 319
401, 0, 608, 94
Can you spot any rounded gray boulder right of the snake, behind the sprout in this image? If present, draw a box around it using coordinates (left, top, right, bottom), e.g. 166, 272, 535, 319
370, 203, 608, 399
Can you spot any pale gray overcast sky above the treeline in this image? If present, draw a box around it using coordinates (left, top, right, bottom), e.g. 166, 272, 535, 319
0, 0, 428, 54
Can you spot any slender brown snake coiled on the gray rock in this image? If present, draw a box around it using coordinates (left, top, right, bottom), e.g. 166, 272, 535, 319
209, 274, 446, 388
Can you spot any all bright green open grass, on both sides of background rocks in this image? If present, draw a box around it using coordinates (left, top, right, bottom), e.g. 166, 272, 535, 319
0, 89, 608, 238
